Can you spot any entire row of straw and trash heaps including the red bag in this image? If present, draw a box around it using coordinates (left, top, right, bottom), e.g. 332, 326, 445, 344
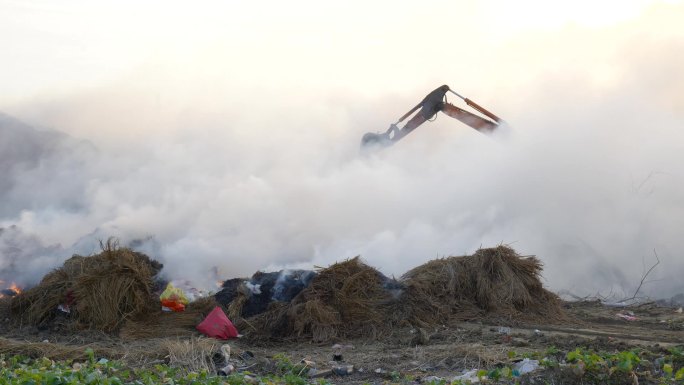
9, 242, 564, 342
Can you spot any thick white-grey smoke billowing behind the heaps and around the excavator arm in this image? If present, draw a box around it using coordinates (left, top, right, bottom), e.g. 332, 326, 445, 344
0, 1, 684, 296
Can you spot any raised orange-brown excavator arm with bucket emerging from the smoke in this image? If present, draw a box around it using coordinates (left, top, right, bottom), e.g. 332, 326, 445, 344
361, 85, 501, 147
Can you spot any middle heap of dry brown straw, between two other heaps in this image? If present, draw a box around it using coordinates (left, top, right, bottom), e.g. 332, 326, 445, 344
239, 257, 392, 342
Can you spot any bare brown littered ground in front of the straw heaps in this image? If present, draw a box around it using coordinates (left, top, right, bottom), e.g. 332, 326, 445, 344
0, 301, 684, 384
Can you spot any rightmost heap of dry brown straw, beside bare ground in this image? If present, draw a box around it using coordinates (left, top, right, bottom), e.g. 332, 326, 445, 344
398, 246, 564, 326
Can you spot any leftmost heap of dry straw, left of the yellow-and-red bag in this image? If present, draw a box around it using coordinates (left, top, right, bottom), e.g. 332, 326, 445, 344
10, 240, 162, 332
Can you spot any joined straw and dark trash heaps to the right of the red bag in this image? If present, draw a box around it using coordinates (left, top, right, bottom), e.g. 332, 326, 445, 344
216, 246, 564, 342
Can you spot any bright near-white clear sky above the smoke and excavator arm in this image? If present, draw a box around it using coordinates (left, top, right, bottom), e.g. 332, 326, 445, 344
0, 0, 682, 107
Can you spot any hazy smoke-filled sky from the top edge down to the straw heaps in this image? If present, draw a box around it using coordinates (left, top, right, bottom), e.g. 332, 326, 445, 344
0, 0, 684, 294
